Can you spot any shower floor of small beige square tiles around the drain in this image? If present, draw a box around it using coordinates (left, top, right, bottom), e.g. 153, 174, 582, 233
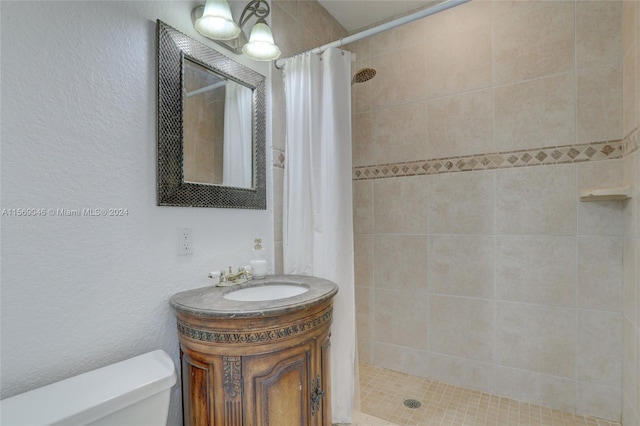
354, 363, 620, 426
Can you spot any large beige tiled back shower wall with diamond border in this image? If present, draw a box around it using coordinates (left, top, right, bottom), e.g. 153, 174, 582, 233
350, 1, 640, 424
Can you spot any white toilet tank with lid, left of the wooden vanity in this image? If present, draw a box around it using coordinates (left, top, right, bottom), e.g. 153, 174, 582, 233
0, 350, 176, 426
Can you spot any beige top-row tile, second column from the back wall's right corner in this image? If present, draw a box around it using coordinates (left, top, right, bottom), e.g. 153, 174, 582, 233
493, 1, 575, 84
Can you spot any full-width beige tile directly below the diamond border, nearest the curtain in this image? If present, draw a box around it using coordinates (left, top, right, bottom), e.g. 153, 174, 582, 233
373, 176, 429, 234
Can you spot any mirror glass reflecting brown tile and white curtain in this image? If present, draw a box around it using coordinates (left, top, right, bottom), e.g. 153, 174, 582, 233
183, 58, 253, 188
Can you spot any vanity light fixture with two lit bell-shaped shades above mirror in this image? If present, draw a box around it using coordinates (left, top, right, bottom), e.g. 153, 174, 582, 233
191, 0, 280, 61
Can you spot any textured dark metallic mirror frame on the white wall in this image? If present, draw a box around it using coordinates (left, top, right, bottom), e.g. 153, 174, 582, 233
157, 20, 267, 210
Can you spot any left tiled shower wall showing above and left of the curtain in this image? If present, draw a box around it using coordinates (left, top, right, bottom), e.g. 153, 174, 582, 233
271, 0, 346, 273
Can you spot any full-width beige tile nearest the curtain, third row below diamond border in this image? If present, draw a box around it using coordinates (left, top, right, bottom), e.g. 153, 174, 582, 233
373, 288, 428, 352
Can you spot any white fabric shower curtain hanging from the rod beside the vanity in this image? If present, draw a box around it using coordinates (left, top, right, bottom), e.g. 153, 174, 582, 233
283, 48, 357, 423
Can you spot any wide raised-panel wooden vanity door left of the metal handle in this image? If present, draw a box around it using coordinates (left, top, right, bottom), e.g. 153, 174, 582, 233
242, 340, 315, 426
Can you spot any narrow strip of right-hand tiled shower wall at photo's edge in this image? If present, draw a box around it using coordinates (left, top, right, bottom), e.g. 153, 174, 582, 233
622, 1, 640, 426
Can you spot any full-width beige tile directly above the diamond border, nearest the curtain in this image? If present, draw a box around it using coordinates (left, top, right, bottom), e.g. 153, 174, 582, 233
371, 102, 428, 164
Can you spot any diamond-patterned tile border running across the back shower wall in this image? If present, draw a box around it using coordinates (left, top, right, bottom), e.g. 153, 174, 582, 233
352, 139, 624, 180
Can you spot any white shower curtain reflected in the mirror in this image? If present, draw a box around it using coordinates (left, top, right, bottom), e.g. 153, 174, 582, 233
222, 81, 253, 188
